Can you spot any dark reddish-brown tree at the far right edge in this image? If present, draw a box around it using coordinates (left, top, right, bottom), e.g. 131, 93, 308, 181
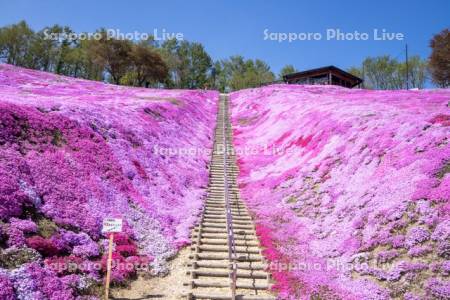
430, 29, 450, 88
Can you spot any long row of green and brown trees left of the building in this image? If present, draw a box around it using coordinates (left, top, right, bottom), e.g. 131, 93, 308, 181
0, 21, 275, 91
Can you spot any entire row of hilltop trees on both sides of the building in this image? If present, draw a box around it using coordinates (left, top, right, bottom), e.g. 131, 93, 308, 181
0, 21, 450, 92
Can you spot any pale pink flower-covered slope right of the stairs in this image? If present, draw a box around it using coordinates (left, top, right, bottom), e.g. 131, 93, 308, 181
231, 85, 450, 299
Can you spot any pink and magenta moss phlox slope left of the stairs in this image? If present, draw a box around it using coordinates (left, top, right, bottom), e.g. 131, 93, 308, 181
0, 64, 218, 299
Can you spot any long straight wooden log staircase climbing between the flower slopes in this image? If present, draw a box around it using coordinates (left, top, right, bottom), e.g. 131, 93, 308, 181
186, 94, 275, 300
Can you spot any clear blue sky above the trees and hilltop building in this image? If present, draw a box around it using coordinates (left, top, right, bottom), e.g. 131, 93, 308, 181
0, 0, 450, 72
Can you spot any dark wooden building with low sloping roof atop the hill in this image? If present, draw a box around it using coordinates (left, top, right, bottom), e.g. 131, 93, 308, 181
283, 66, 363, 88
